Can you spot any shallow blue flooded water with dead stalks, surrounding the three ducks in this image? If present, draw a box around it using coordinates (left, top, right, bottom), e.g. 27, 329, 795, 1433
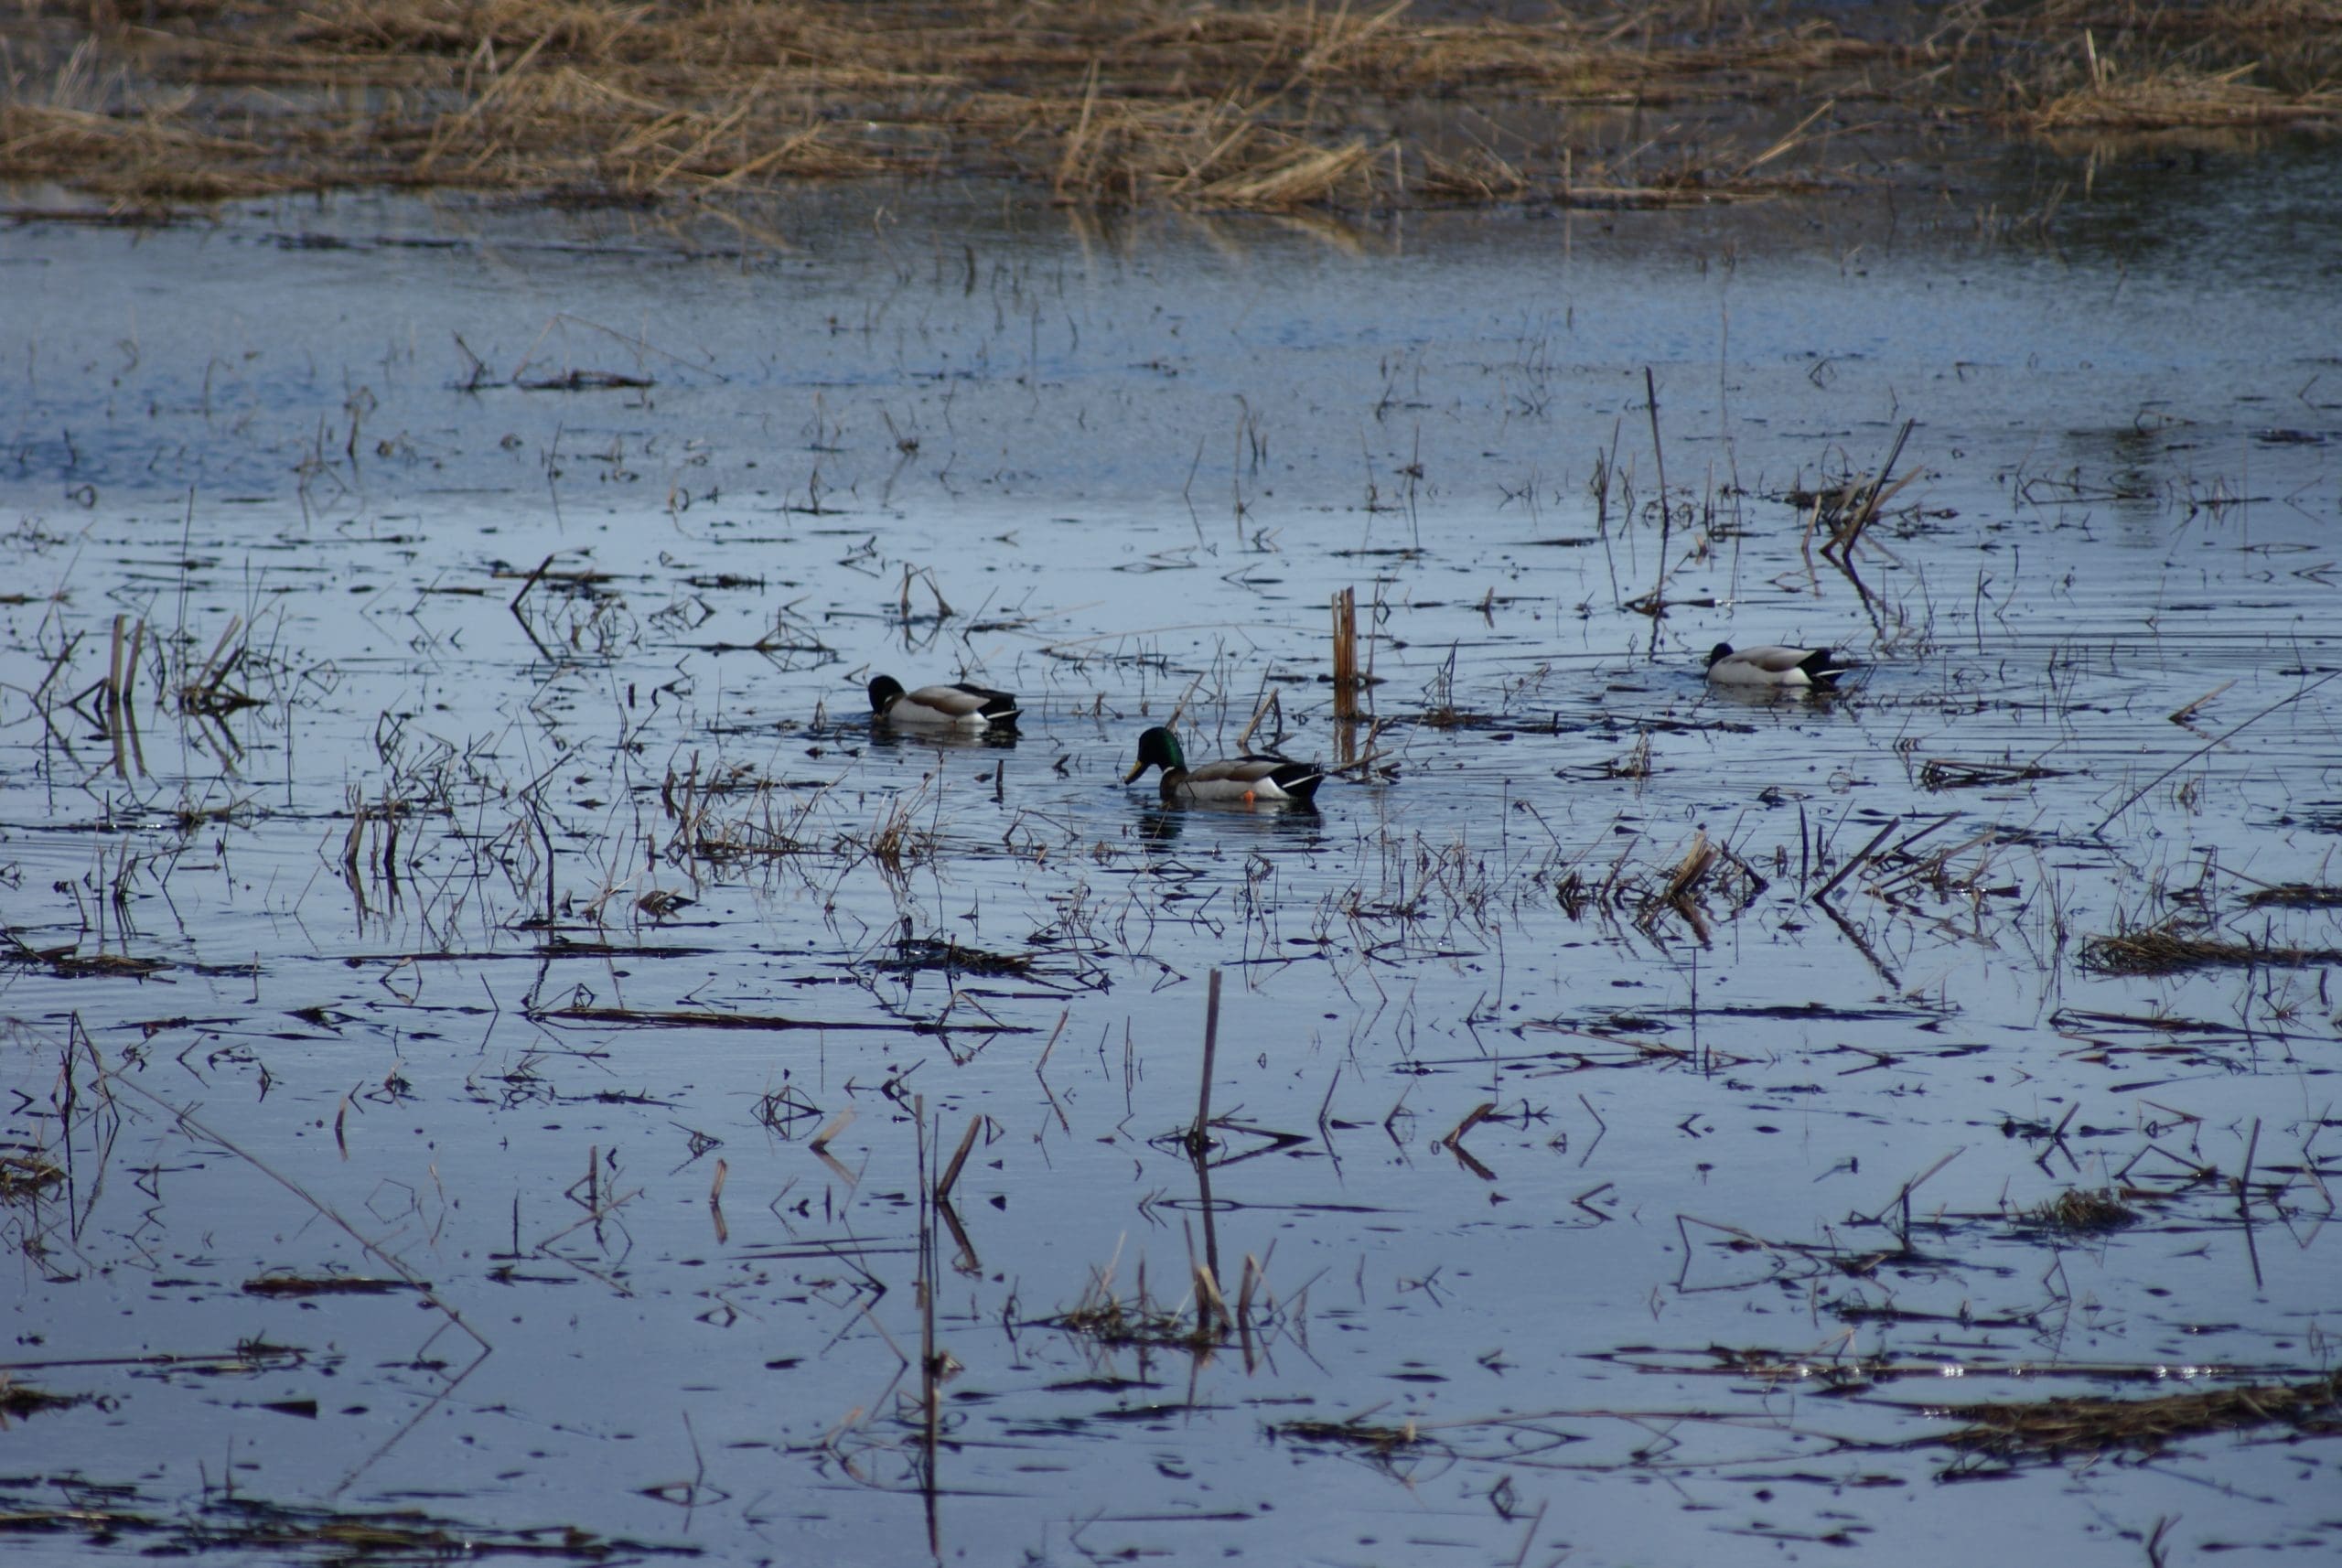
0, 155, 2342, 1565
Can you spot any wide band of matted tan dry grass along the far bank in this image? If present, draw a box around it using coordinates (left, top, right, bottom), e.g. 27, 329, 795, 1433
0, 0, 2342, 210
